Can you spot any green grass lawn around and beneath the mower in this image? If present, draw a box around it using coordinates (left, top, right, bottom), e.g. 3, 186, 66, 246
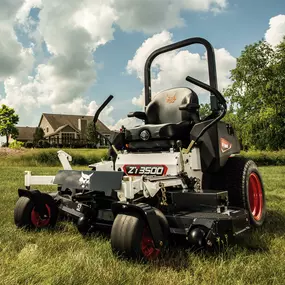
0, 162, 285, 285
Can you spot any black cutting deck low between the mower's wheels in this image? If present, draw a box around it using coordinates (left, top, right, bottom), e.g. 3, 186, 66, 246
50, 185, 250, 245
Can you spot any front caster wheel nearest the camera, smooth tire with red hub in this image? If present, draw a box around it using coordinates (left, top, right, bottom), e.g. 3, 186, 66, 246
111, 213, 164, 260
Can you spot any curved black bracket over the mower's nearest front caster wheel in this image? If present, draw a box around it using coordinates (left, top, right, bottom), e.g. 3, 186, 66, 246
112, 202, 169, 248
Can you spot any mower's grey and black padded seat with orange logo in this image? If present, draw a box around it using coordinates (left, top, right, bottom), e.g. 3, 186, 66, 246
125, 88, 200, 148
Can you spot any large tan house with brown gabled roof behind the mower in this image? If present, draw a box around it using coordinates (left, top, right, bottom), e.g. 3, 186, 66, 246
38, 113, 112, 146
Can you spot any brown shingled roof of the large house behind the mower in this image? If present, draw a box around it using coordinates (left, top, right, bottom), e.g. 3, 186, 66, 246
40, 113, 112, 133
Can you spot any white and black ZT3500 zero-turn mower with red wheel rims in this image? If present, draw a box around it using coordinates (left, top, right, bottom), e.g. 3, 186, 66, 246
14, 38, 266, 259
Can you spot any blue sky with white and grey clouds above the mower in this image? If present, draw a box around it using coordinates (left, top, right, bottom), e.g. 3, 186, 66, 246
0, 0, 285, 136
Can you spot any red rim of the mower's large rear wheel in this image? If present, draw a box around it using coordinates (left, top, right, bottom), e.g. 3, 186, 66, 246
248, 172, 263, 221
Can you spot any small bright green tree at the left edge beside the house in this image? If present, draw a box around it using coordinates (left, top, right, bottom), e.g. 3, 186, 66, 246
0, 104, 19, 146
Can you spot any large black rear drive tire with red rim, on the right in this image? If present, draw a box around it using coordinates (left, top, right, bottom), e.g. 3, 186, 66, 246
203, 156, 266, 227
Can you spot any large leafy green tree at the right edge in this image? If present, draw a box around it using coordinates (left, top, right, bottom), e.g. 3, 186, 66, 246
224, 39, 285, 150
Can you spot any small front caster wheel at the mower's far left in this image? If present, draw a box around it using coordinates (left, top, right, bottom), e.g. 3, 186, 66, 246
14, 193, 58, 229
